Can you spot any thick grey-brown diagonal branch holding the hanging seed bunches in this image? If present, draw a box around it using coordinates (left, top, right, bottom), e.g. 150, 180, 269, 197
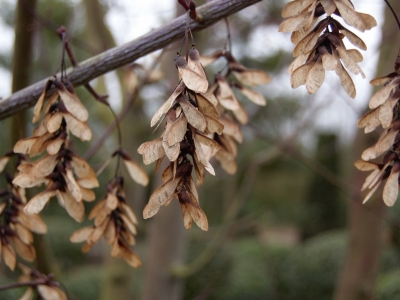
0, 0, 261, 119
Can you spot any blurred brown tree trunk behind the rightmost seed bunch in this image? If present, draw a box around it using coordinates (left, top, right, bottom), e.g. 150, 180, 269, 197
333, 1, 400, 300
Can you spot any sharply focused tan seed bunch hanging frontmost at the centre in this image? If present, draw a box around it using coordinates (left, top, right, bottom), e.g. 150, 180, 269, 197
138, 45, 223, 230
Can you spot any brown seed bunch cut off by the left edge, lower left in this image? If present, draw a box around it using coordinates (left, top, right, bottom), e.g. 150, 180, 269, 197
0, 152, 47, 270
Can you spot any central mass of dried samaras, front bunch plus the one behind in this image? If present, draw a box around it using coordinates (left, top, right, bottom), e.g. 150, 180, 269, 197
138, 46, 270, 230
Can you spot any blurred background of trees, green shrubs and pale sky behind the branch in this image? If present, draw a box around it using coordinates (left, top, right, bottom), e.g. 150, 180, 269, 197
0, 0, 400, 300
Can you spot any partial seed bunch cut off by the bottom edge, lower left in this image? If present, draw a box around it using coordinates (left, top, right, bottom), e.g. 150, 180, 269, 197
18, 263, 68, 300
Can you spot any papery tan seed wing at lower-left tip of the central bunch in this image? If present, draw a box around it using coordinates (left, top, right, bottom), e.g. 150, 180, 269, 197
143, 177, 181, 219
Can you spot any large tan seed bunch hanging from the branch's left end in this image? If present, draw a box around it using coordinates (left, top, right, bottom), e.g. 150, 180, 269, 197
13, 77, 99, 222
